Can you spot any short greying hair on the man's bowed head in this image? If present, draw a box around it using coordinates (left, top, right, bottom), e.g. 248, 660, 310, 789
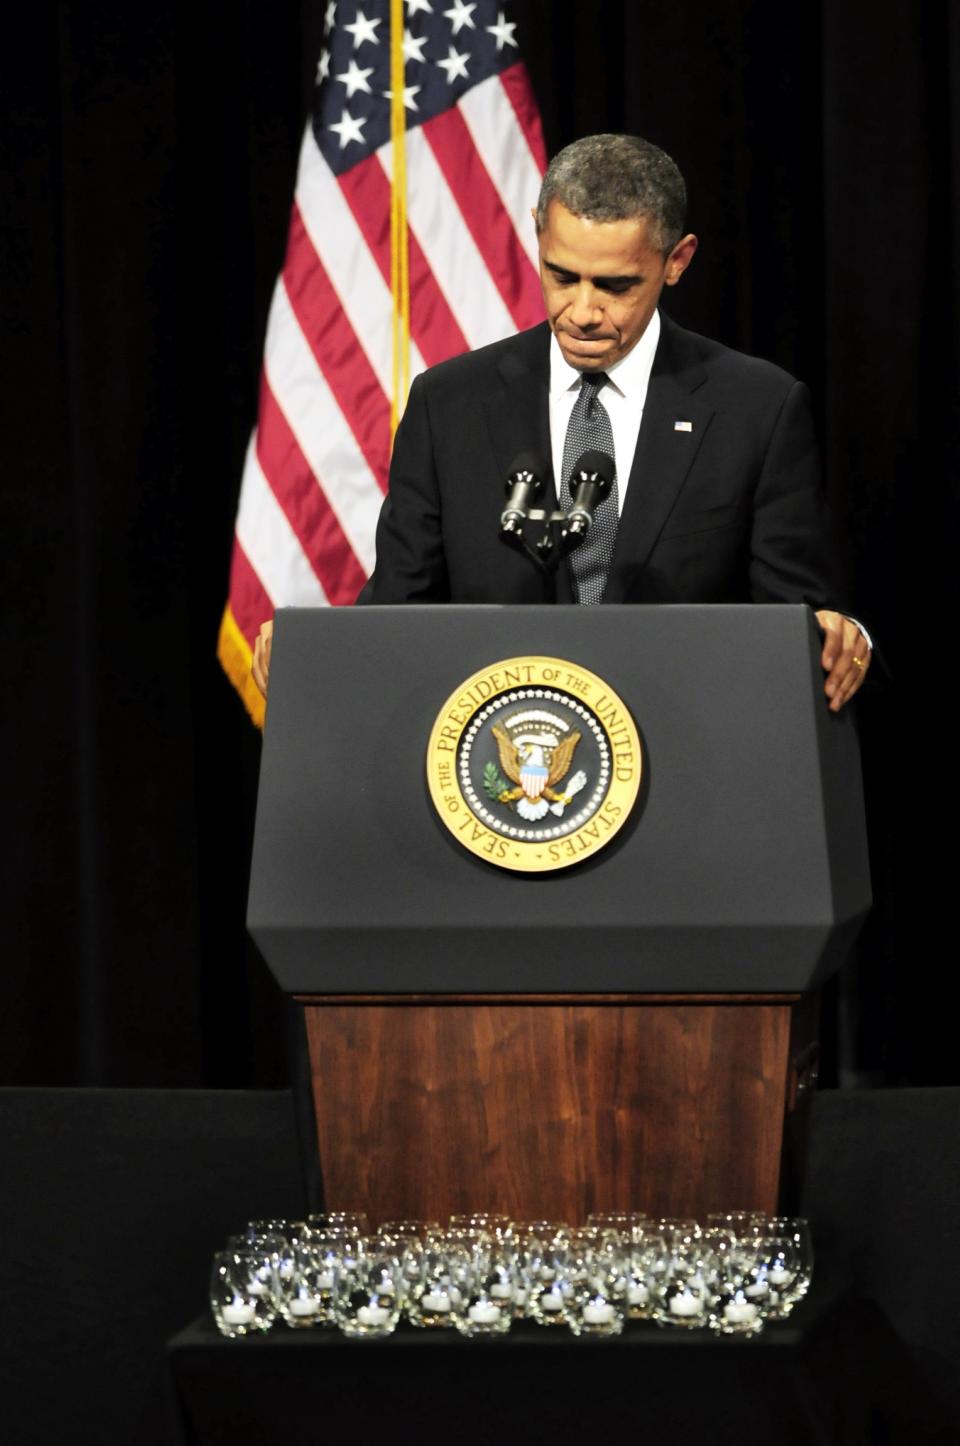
536, 136, 687, 254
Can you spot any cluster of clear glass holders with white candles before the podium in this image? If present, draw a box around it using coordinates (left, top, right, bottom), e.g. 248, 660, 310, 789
210, 1210, 813, 1339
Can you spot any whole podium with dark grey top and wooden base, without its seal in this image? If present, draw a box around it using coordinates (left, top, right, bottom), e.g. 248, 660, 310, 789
247, 606, 870, 1220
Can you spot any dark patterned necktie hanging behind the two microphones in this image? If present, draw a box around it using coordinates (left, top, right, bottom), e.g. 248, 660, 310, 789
560, 372, 620, 604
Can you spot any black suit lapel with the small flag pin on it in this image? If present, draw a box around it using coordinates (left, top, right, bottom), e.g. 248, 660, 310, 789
603, 315, 713, 603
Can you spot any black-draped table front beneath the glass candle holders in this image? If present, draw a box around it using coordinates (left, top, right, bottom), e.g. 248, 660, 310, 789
168, 1293, 951, 1446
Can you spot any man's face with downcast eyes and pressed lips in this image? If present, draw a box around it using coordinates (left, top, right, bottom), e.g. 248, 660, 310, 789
538, 201, 697, 372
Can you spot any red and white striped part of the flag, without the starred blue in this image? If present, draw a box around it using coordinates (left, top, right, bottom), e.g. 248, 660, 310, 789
219, 64, 545, 646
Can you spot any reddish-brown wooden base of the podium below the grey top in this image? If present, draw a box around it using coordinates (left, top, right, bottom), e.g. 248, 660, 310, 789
299, 995, 817, 1223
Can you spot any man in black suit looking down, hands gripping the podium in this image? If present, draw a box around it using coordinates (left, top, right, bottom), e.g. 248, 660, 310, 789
253, 134, 870, 711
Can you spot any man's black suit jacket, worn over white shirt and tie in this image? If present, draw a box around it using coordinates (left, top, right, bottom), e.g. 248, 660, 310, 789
360, 317, 846, 609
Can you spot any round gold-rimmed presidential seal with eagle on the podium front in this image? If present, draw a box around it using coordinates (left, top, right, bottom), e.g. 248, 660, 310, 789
427, 658, 642, 872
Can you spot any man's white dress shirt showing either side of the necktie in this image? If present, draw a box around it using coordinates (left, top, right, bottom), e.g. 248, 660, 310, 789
549, 311, 659, 512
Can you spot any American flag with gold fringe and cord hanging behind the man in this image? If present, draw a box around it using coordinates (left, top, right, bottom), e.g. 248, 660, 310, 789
218, 0, 545, 722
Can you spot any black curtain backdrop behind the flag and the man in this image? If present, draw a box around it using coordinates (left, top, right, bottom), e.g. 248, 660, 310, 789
0, 0, 960, 1086
